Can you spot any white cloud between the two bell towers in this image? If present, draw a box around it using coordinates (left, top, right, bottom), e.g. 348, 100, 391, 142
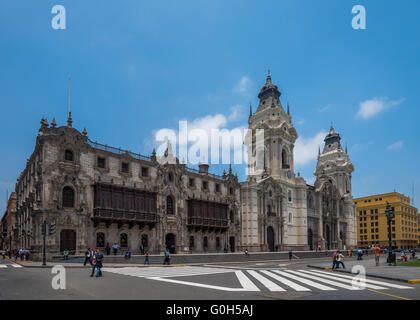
295, 131, 327, 165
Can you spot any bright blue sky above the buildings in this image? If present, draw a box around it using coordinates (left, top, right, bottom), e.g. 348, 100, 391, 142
0, 0, 420, 211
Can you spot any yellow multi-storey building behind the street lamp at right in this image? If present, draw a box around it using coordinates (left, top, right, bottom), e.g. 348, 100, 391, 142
353, 192, 419, 249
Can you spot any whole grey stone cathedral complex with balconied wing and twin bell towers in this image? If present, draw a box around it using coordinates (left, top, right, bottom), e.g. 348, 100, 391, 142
15, 75, 356, 258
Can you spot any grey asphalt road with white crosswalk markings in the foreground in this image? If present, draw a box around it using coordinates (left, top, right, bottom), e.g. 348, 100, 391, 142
0, 260, 420, 300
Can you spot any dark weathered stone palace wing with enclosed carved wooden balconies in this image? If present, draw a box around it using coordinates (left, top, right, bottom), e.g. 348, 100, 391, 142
16, 117, 241, 258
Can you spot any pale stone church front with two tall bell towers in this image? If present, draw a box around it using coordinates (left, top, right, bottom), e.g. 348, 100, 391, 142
241, 75, 356, 251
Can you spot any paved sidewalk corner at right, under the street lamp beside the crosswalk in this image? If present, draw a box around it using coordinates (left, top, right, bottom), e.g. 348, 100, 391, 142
308, 254, 420, 283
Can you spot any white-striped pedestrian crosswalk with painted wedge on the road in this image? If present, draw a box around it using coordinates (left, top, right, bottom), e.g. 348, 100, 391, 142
103, 267, 413, 292
